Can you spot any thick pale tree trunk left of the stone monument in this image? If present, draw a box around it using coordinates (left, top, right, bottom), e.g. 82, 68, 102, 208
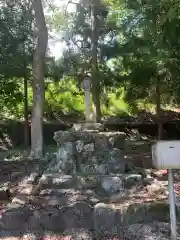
29, 0, 48, 159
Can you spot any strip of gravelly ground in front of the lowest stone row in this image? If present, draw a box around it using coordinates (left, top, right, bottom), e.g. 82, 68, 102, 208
0, 222, 180, 240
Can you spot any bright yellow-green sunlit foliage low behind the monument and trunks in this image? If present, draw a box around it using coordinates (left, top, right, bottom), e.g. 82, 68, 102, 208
0, 77, 160, 119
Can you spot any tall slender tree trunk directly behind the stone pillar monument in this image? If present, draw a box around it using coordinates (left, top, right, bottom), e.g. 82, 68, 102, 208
91, 0, 101, 122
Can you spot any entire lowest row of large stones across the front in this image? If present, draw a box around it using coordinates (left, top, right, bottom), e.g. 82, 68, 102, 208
1, 195, 180, 235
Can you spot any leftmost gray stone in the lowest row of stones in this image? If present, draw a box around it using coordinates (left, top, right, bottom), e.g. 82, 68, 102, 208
2, 203, 32, 230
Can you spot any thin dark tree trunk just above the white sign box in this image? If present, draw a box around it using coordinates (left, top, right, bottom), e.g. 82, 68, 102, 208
156, 77, 163, 140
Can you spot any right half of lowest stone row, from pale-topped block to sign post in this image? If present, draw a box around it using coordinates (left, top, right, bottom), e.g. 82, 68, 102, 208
94, 202, 174, 231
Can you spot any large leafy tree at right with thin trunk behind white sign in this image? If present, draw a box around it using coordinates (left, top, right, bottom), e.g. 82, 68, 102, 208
104, 0, 180, 138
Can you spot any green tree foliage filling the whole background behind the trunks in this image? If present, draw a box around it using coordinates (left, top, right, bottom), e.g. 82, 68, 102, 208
0, 0, 180, 122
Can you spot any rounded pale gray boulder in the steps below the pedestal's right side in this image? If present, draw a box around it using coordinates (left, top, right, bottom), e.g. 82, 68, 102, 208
101, 176, 124, 195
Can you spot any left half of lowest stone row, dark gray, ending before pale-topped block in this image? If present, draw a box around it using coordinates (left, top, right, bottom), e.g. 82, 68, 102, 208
0, 202, 93, 232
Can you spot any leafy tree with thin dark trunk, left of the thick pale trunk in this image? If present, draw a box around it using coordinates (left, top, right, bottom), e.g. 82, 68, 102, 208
0, 0, 34, 146
